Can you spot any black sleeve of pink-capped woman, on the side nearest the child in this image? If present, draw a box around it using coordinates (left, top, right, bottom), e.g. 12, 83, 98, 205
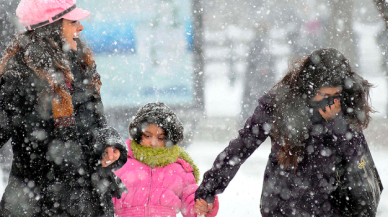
73, 62, 128, 169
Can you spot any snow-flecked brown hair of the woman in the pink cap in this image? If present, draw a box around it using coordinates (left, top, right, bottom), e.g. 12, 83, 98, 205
0, 19, 94, 81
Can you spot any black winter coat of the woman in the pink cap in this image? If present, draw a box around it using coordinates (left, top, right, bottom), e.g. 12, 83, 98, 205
0, 49, 127, 217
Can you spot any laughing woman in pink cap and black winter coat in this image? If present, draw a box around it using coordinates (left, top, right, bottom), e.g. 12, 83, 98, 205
0, 0, 127, 217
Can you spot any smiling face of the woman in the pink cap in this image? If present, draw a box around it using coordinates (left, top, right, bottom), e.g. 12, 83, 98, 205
62, 19, 84, 50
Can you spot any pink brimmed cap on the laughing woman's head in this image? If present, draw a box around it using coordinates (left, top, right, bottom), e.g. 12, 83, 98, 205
16, 0, 90, 30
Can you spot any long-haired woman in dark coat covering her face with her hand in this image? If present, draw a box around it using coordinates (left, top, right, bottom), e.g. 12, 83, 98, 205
196, 49, 382, 216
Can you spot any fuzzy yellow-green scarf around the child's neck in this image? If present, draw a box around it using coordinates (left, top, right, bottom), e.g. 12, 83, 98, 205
131, 140, 199, 183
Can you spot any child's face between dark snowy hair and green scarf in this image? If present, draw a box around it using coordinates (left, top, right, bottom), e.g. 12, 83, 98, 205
140, 124, 166, 148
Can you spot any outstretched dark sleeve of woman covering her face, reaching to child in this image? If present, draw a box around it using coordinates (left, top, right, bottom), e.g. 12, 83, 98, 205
195, 95, 271, 203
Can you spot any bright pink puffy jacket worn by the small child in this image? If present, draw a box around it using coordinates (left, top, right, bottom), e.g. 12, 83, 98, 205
113, 139, 219, 217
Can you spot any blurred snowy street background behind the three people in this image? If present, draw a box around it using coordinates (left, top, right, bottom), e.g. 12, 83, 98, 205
0, 0, 388, 216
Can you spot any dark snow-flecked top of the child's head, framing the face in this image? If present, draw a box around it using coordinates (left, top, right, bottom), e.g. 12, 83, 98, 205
129, 102, 183, 147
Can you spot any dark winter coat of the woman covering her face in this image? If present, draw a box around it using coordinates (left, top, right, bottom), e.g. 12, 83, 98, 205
196, 94, 378, 217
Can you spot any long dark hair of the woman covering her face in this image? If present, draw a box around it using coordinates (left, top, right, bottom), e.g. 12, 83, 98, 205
271, 48, 373, 169
